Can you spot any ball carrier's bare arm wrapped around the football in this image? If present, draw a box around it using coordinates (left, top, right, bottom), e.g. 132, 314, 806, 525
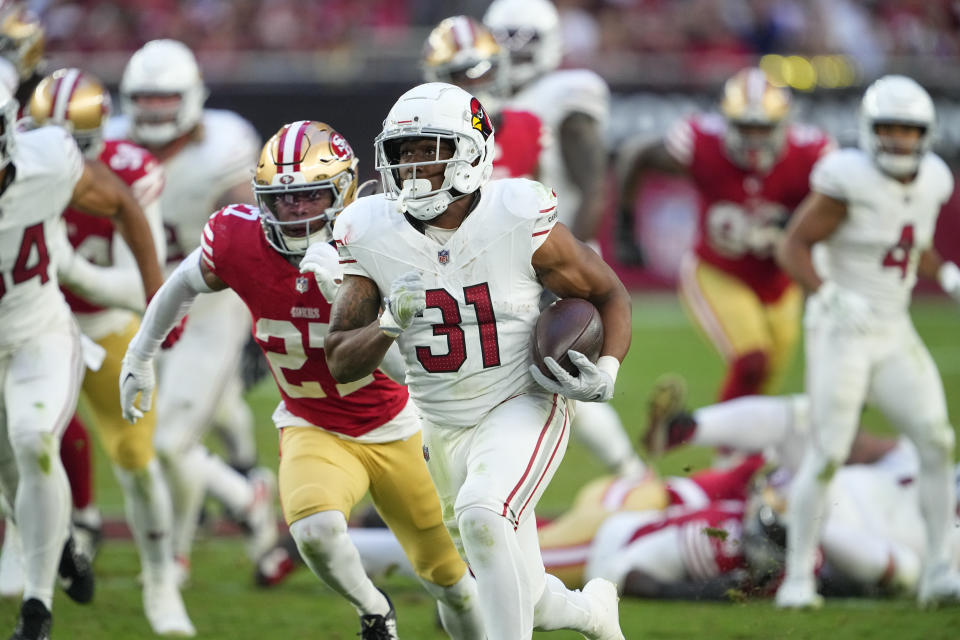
532, 223, 633, 362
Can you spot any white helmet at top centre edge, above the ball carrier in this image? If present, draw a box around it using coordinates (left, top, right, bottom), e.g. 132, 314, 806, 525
483, 0, 563, 88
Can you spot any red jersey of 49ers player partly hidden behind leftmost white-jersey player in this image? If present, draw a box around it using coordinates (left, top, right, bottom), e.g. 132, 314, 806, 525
62, 140, 163, 313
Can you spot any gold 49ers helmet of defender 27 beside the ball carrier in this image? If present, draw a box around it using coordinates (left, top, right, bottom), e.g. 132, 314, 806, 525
253, 120, 358, 256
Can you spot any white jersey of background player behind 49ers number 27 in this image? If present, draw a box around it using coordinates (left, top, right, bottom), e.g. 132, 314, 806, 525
106, 109, 260, 271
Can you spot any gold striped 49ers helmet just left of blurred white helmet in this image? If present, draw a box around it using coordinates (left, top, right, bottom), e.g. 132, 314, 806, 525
28, 68, 110, 158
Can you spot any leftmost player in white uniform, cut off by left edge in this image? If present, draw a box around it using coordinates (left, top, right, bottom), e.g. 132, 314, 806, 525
0, 81, 163, 640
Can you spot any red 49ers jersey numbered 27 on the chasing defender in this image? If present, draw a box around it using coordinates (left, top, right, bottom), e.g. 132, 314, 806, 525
201, 204, 408, 437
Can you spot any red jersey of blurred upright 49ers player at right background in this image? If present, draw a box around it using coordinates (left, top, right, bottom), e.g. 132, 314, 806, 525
665, 114, 834, 302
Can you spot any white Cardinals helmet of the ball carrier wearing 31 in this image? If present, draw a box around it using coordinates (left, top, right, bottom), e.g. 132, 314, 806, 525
373, 82, 494, 220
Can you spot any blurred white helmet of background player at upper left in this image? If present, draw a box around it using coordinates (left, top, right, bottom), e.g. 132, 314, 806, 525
120, 40, 208, 147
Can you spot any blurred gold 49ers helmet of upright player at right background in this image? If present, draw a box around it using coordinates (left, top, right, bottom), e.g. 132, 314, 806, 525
720, 67, 790, 172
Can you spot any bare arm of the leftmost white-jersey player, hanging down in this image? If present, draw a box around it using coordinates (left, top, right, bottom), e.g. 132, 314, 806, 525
70, 160, 163, 298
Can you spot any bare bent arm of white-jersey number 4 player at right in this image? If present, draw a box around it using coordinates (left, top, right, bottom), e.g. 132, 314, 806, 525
776, 191, 847, 293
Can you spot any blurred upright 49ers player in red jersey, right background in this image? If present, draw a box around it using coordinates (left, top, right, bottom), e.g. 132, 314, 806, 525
619, 68, 834, 400
